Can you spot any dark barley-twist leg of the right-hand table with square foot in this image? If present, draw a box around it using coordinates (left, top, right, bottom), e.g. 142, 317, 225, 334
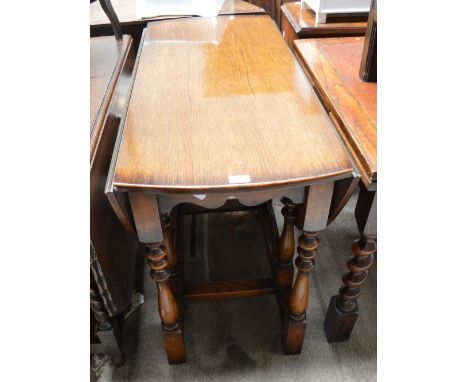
324, 188, 377, 342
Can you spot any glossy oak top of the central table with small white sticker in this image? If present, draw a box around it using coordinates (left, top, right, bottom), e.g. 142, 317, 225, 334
114, 16, 353, 193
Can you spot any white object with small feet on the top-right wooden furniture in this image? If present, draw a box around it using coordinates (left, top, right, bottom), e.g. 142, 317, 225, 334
302, 0, 371, 24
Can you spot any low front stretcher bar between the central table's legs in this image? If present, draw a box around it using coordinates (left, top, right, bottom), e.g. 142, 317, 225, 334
184, 279, 276, 300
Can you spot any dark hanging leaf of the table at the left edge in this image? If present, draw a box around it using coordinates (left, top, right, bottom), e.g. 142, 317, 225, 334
90, 35, 138, 315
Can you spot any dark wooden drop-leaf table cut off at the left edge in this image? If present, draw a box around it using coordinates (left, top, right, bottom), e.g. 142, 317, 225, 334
90, 35, 138, 364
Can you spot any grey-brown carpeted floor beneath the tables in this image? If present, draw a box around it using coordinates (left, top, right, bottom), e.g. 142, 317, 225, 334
91, 195, 377, 382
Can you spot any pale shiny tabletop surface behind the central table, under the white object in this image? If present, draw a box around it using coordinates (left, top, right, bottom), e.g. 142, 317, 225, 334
90, 0, 265, 28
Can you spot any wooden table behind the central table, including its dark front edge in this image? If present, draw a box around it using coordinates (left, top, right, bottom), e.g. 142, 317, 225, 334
90, 0, 265, 46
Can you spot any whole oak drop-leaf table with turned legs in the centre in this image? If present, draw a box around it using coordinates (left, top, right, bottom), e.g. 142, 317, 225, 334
106, 16, 358, 363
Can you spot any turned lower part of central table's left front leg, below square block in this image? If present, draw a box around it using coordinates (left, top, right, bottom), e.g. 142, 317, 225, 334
146, 242, 185, 364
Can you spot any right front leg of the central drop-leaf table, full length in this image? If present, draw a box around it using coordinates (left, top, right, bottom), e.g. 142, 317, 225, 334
283, 182, 333, 354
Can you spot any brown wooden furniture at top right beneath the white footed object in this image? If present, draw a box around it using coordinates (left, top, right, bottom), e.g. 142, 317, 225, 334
281, 1, 367, 49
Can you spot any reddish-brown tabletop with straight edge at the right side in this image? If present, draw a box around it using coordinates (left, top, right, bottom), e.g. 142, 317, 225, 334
294, 37, 377, 186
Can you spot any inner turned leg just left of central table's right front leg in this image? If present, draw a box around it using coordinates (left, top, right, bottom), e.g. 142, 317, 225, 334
276, 198, 296, 290
